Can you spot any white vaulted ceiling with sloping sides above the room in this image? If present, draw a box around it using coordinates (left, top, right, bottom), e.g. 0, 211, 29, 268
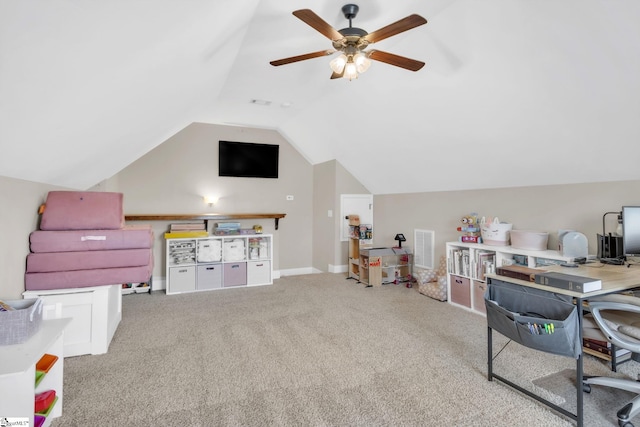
0, 0, 640, 194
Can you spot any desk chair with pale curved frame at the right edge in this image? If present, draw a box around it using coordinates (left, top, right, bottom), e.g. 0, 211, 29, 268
583, 295, 640, 427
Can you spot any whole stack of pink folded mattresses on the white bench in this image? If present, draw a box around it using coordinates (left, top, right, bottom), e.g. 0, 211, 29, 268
25, 191, 153, 291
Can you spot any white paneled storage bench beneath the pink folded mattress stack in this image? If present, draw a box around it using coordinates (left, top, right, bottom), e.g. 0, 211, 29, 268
22, 285, 122, 357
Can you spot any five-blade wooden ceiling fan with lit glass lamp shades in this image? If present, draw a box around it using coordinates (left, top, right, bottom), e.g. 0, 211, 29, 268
270, 4, 427, 80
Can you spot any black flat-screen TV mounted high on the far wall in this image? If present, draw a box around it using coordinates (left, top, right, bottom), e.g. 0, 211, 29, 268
218, 141, 280, 178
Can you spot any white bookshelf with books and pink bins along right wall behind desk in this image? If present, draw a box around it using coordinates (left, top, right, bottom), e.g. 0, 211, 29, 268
446, 242, 573, 314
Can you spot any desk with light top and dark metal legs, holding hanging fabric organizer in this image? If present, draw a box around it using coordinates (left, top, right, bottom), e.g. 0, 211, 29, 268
487, 264, 640, 427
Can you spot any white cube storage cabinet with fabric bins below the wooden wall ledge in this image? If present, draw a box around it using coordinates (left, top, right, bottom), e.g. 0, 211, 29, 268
166, 234, 273, 295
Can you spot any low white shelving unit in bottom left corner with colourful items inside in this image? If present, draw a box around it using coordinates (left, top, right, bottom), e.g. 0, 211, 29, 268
0, 319, 71, 426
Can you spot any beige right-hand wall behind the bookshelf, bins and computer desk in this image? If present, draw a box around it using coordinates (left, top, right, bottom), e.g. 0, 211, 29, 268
374, 181, 640, 263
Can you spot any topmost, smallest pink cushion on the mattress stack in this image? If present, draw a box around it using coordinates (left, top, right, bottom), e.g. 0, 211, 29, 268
40, 191, 124, 230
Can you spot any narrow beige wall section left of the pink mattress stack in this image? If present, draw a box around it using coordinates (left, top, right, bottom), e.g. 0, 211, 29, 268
0, 177, 70, 299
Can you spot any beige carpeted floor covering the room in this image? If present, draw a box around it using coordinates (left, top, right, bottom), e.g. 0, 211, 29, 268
53, 274, 639, 427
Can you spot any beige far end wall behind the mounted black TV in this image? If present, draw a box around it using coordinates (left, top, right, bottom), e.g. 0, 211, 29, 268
112, 123, 313, 278
